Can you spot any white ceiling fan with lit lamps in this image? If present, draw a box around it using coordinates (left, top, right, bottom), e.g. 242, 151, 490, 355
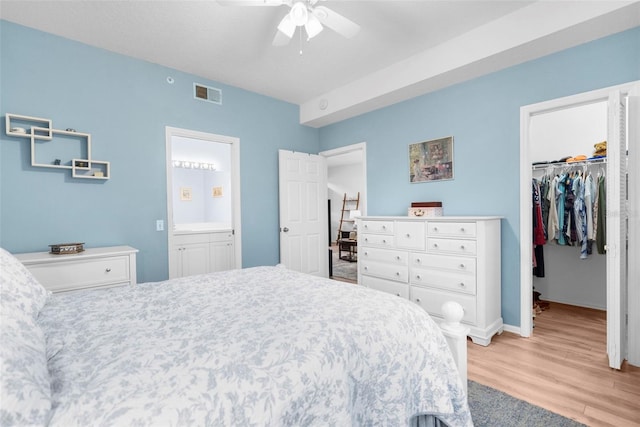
218, 0, 360, 46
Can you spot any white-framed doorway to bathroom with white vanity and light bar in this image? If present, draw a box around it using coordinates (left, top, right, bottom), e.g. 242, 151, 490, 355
166, 127, 242, 278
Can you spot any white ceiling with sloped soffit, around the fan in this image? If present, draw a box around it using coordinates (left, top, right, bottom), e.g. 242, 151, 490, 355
0, 0, 640, 127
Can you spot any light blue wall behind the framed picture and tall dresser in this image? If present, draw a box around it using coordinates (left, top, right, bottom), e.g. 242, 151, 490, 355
320, 28, 640, 325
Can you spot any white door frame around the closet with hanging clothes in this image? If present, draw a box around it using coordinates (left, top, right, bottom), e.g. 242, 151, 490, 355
520, 81, 640, 366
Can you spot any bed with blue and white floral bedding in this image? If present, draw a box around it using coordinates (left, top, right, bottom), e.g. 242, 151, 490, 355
0, 249, 472, 427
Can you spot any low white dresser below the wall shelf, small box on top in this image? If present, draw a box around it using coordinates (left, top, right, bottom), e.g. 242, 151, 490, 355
15, 246, 138, 292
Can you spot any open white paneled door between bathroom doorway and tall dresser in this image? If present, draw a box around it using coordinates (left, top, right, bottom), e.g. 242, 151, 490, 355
278, 150, 329, 277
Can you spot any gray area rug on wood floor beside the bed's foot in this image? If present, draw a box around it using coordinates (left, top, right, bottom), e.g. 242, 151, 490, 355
468, 381, 584, 427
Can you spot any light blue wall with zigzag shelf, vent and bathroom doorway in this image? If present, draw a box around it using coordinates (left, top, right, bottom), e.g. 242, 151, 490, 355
0, 21, 319, 282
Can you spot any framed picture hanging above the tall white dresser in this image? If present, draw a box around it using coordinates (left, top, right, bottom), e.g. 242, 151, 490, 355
409, 136, 453, 182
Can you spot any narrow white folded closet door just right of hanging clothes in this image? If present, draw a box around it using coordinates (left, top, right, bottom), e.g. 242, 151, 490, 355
606, 90, 627, 369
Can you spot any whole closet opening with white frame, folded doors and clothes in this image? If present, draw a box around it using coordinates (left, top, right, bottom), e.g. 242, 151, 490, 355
520, 81, 640, 369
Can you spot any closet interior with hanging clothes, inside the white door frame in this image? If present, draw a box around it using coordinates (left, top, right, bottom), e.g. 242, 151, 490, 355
530, 101, 607, 314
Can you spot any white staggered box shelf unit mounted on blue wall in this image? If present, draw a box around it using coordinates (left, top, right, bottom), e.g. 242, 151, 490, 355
5, 113, 111, 180
